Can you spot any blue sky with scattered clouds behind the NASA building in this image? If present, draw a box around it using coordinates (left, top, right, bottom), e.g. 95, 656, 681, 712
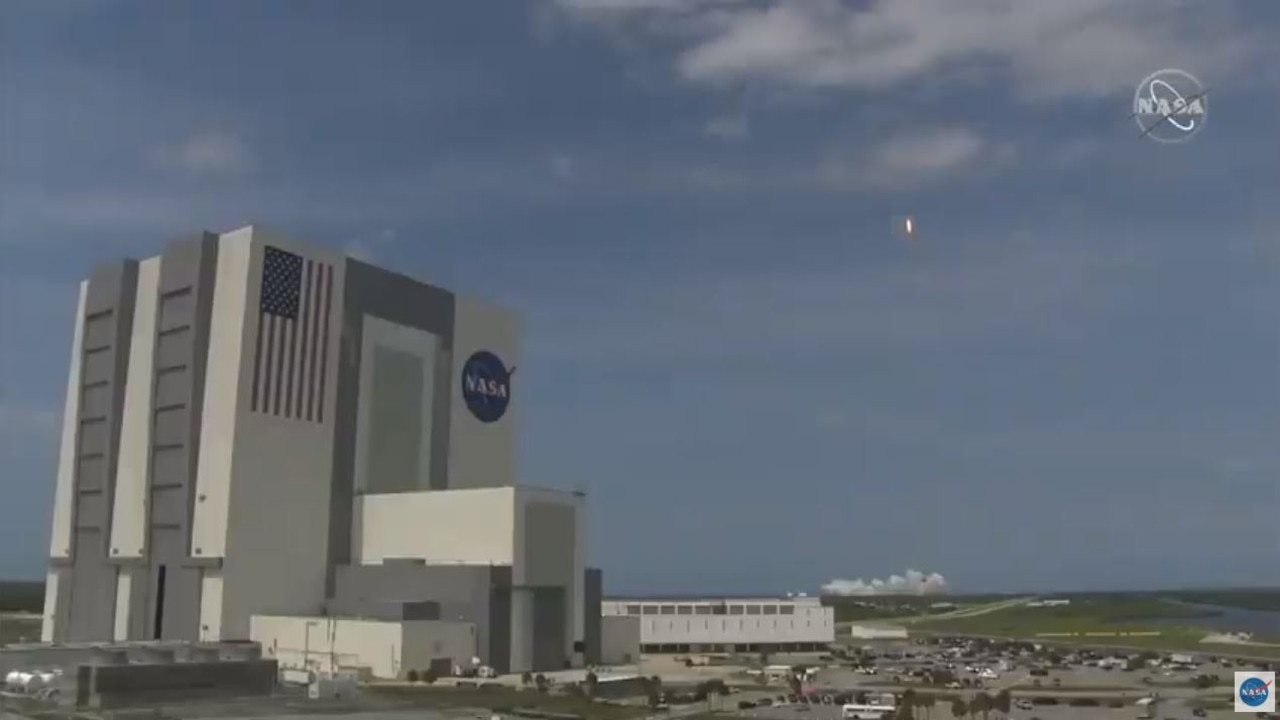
0, 0, 1280, 592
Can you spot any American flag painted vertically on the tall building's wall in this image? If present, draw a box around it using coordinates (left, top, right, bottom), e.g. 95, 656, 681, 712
251, 247, 333, 423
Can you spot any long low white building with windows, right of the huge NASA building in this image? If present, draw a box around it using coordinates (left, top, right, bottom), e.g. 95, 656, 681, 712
600, 597, 836, 653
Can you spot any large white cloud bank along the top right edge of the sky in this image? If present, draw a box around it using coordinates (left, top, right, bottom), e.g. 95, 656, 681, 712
559, 0, 1275, 100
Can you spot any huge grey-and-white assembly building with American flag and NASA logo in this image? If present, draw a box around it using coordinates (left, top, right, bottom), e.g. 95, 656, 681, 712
42, 227, 600, 676
